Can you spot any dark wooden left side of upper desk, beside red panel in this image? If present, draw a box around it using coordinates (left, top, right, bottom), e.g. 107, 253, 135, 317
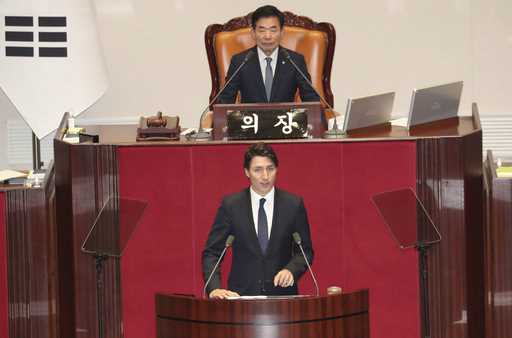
54, 140, 122, 338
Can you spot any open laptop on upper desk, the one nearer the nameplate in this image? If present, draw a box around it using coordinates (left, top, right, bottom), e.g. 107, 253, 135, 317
343, 92, 395, 132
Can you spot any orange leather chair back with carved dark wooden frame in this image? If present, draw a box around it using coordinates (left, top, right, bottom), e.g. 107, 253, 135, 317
205, 12, 336, 106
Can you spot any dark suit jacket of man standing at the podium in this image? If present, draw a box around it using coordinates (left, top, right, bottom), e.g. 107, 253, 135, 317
203, 188, 313, 295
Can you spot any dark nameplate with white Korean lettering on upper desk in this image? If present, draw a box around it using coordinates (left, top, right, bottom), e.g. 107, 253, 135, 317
227, 108, 308, 140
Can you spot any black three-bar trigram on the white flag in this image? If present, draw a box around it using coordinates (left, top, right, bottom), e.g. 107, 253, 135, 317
5, 16, 68, 57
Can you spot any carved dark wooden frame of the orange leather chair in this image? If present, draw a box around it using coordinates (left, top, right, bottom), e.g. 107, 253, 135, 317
204, 12, 336, 107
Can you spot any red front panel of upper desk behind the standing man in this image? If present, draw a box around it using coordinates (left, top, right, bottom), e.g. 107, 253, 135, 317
118, 142, 420, 338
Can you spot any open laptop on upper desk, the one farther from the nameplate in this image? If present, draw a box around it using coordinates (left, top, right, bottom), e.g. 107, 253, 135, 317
407, 81, 463, 129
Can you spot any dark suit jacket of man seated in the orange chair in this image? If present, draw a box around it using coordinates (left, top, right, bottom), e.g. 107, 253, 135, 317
219, 46, 320, 103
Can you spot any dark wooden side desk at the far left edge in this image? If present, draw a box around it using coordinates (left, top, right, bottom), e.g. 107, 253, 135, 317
6, 167, 58, 338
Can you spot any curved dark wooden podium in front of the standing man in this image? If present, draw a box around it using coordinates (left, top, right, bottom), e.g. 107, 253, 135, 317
156, 290, 369, 338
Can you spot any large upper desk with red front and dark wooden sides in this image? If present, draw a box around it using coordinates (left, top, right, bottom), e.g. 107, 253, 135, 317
54, 111, 484, 338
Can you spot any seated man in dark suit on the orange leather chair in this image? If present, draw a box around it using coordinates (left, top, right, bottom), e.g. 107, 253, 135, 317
203, 6, 320, 127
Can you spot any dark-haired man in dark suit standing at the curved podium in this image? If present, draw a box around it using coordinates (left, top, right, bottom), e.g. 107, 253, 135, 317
203, 143, 313, 299
